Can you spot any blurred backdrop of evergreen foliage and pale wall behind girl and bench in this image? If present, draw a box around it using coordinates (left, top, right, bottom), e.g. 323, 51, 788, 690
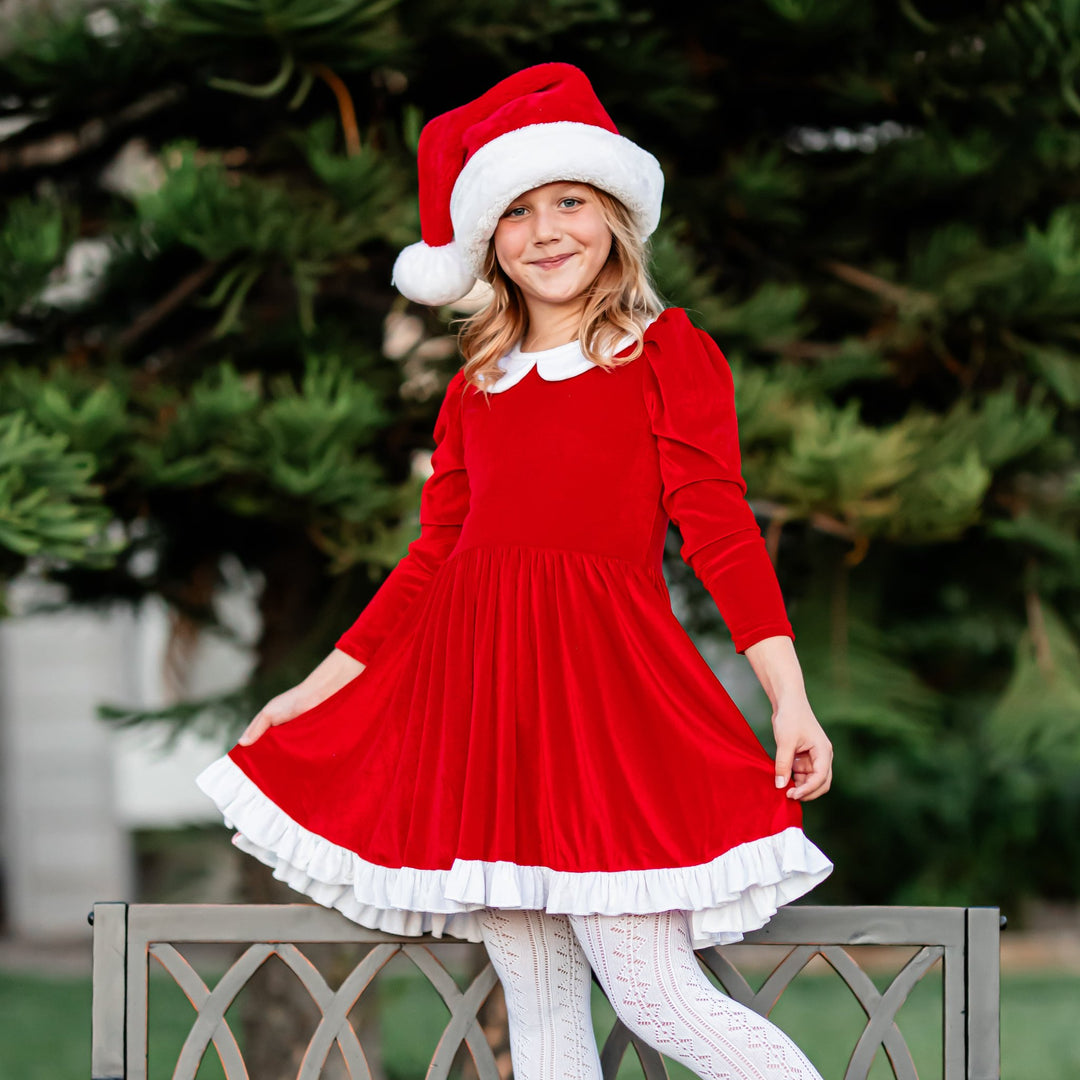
0, 0, 1080, 1080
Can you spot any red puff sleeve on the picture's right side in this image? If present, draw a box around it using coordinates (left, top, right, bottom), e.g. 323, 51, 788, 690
643, 308, 795, 652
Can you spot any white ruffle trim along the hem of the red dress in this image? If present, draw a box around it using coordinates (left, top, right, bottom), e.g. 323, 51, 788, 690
195, 755, 833, 948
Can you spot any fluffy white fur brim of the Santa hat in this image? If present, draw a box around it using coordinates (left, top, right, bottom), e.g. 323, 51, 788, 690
450, 120, 664, 278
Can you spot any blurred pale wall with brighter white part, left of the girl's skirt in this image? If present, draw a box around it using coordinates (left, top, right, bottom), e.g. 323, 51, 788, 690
0, 565, 257, 937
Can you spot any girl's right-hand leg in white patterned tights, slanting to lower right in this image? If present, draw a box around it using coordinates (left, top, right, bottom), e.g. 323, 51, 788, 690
568, 912, 821, 1080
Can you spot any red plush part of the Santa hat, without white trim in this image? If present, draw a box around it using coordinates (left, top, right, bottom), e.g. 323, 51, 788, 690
417, 64, 619, 247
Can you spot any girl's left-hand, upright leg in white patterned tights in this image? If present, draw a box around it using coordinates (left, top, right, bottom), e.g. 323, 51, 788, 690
478, 907, 602, 1080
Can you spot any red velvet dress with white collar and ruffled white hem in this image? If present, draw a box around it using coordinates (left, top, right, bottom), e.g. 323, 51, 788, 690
199, 309, 832, 947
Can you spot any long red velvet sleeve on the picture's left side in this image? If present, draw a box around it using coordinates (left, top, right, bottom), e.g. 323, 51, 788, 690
336, 370, 469, 664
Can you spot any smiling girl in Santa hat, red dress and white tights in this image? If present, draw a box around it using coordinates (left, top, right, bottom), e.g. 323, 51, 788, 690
199, 64, 832, 1080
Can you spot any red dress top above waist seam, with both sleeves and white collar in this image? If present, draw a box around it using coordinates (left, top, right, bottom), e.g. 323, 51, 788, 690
338, 308, 794, 662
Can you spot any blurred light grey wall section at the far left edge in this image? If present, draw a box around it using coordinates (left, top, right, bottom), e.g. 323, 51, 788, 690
0, 600, 135, 936
